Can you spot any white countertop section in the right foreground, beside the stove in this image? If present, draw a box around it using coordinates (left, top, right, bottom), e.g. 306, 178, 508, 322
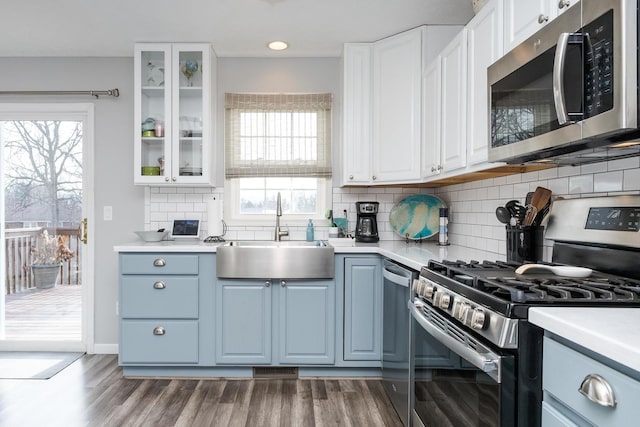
529, 307, 640, 372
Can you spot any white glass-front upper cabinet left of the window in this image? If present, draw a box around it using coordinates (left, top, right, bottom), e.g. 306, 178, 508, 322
134, 43, 215, 186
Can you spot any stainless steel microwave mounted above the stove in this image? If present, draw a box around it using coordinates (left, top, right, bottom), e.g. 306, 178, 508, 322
488, 0, 640, 164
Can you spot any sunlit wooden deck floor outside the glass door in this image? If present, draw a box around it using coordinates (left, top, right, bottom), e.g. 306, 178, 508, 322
5, 285, 82, 341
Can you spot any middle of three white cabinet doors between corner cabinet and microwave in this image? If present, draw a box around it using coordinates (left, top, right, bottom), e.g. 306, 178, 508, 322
441, 29, 467, 172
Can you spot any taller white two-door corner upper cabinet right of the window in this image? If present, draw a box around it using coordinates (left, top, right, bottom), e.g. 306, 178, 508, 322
342, 25, 461, 185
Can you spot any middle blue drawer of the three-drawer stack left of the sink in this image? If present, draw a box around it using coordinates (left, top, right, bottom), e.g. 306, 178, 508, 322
120, 276, 198, 319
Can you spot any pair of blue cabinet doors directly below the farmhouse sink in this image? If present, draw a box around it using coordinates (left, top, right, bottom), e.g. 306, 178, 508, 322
215, 279, 335, 365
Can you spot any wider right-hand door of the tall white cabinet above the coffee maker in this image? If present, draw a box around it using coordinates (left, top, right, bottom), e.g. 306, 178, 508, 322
371, 27, 424, 183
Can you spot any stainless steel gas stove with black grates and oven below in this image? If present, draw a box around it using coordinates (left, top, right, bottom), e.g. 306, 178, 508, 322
409, 196, 640, 427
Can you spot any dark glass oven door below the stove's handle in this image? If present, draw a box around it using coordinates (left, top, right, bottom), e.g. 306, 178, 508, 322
412, 319, 516, 427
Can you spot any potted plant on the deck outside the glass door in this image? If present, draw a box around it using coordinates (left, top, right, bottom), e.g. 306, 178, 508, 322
31, 230, 73, 289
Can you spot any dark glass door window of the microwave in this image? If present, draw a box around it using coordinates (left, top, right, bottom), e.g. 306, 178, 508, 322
491, 42, 583, 148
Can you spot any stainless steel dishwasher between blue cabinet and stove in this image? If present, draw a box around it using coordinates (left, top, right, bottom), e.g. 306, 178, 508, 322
382, 259, 418, 426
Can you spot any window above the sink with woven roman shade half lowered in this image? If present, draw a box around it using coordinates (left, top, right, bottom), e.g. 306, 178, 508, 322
225, 93, 331, 223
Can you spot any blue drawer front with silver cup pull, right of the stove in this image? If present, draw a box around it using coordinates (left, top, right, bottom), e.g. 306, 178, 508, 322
542, 337, 640, 427
